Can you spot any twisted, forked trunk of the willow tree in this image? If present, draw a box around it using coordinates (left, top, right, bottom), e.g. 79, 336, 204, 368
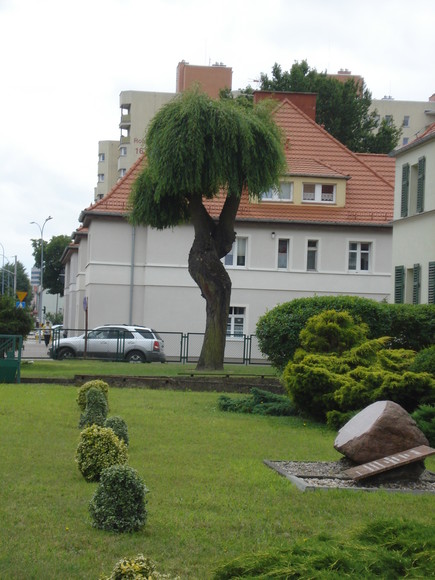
189, 196, 240, 370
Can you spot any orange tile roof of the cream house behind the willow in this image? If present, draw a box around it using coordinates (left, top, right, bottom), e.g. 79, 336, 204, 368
80, 100, 395, 225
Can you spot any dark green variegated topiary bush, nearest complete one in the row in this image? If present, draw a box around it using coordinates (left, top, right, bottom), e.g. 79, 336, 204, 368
89, 465, 148, 532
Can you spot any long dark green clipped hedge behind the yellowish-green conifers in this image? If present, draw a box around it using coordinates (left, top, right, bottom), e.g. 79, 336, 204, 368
256, 296, 435, 369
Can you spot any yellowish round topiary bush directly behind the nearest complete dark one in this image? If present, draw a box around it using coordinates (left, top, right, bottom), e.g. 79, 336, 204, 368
76, 425, 128, 481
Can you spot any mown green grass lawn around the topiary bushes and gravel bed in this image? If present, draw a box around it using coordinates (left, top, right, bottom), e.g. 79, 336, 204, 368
0, 382, 435, 580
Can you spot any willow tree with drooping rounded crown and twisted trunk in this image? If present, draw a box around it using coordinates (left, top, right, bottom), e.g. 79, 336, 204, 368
130, 89, 285, 369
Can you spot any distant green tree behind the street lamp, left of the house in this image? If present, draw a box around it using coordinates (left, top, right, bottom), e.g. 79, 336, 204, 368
32, 236, 71, 296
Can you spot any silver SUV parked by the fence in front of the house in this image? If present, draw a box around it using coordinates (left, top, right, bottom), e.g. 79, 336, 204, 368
48, 324, 166, 363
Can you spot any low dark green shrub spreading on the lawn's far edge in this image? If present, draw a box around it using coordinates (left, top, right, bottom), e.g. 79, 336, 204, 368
218, 388, 295, 416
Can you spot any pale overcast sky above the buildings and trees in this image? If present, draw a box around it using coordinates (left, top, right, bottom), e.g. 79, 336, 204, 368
0, 0, 435, 275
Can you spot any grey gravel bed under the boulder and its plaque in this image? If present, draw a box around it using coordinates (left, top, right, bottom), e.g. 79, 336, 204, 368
264, 460, 435, 494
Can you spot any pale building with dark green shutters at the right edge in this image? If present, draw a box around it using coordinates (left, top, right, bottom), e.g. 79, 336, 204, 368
392, 123, 435, 304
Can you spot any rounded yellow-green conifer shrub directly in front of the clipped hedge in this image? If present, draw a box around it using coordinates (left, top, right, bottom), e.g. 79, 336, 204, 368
299, 310, 369, 354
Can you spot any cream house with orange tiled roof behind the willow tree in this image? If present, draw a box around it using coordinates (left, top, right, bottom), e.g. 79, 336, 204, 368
64, 93, 395, 356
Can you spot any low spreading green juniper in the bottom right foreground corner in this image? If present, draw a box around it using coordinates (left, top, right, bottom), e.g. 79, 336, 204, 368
213, 519, 435, 580
